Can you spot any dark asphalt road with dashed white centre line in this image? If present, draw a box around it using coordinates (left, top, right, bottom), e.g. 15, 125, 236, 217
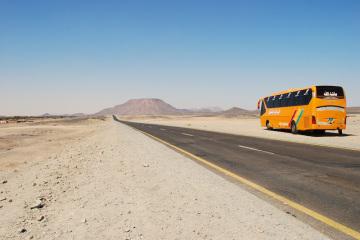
115, 118, 360, 234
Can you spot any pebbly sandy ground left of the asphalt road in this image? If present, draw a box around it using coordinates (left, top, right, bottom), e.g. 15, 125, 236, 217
0, 119, 327, 239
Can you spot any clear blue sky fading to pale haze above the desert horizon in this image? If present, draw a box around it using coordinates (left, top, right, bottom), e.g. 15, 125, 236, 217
0, 0, 360, 115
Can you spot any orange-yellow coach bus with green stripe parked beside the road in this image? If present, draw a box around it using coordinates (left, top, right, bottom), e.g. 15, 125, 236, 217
258, 86, 346, 135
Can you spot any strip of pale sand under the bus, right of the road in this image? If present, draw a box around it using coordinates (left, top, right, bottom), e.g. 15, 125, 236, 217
122, 115, 360, 150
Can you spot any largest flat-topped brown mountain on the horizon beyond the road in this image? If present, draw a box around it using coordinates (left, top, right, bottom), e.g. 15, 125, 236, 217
96, 98, 189, 115
